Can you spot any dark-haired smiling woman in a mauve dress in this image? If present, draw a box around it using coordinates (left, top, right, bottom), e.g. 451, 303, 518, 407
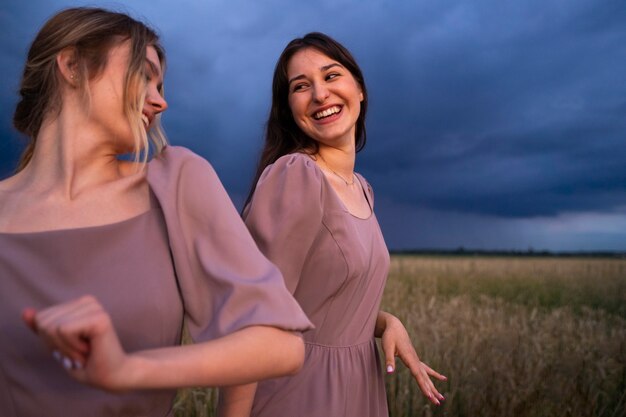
220, 33, 445, 417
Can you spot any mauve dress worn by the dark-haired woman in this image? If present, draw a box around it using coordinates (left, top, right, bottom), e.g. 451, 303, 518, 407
244, 153, 389, 417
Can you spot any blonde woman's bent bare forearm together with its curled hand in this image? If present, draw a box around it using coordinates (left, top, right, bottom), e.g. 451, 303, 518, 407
23, 296, 304, 391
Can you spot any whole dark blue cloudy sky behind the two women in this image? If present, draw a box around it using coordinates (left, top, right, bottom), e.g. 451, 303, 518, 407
0, 0, 626, 251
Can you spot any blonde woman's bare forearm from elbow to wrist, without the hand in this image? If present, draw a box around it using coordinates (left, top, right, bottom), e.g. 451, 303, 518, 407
119, 326, 304, 389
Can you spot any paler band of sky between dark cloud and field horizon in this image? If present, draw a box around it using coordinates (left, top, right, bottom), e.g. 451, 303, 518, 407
377, 199, 626, 251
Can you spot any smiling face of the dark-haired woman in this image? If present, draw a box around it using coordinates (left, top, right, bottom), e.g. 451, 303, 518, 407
287, 48, 363, 147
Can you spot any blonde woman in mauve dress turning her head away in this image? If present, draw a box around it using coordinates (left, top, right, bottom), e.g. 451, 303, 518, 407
0, 8, 310, 417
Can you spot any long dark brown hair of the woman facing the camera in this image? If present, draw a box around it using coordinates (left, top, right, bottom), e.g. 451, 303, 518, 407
244, 32, 367, 206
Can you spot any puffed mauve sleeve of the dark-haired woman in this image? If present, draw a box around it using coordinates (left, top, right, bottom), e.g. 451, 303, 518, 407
243, 153, 323, 294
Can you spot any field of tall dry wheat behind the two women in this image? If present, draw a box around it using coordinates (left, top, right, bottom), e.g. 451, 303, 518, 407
175, 255, 626, 417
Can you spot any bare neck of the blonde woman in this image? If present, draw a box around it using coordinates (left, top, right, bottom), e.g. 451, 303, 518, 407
18, 111, 128, 200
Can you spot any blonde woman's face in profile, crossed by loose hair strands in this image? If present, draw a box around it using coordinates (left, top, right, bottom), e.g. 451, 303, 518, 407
89, 41, 167, 152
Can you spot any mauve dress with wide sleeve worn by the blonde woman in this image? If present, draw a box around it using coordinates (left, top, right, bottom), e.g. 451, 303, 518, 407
0, 147, 311, 417
